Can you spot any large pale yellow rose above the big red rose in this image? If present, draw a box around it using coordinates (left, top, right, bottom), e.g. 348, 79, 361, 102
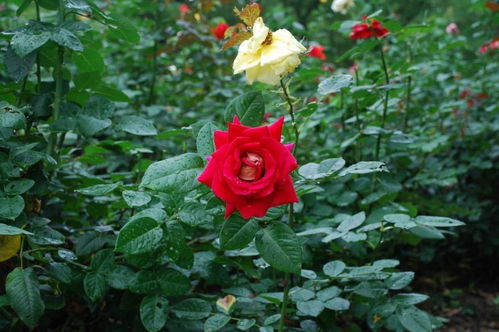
232, 17, 306, 85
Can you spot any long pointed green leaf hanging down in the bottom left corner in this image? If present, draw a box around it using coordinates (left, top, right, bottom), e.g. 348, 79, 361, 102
5, 267, 45, 329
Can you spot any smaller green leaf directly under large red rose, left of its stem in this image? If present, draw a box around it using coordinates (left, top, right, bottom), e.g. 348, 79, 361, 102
220, 215, 260, 250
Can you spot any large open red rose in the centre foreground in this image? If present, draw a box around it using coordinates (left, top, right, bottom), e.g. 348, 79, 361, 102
198, 116, 298, 219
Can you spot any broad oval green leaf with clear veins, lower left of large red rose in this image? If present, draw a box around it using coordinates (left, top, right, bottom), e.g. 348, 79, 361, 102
115, 217, 163, 254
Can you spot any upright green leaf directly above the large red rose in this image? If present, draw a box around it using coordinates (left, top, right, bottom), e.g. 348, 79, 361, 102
224, 92, 265, 127
